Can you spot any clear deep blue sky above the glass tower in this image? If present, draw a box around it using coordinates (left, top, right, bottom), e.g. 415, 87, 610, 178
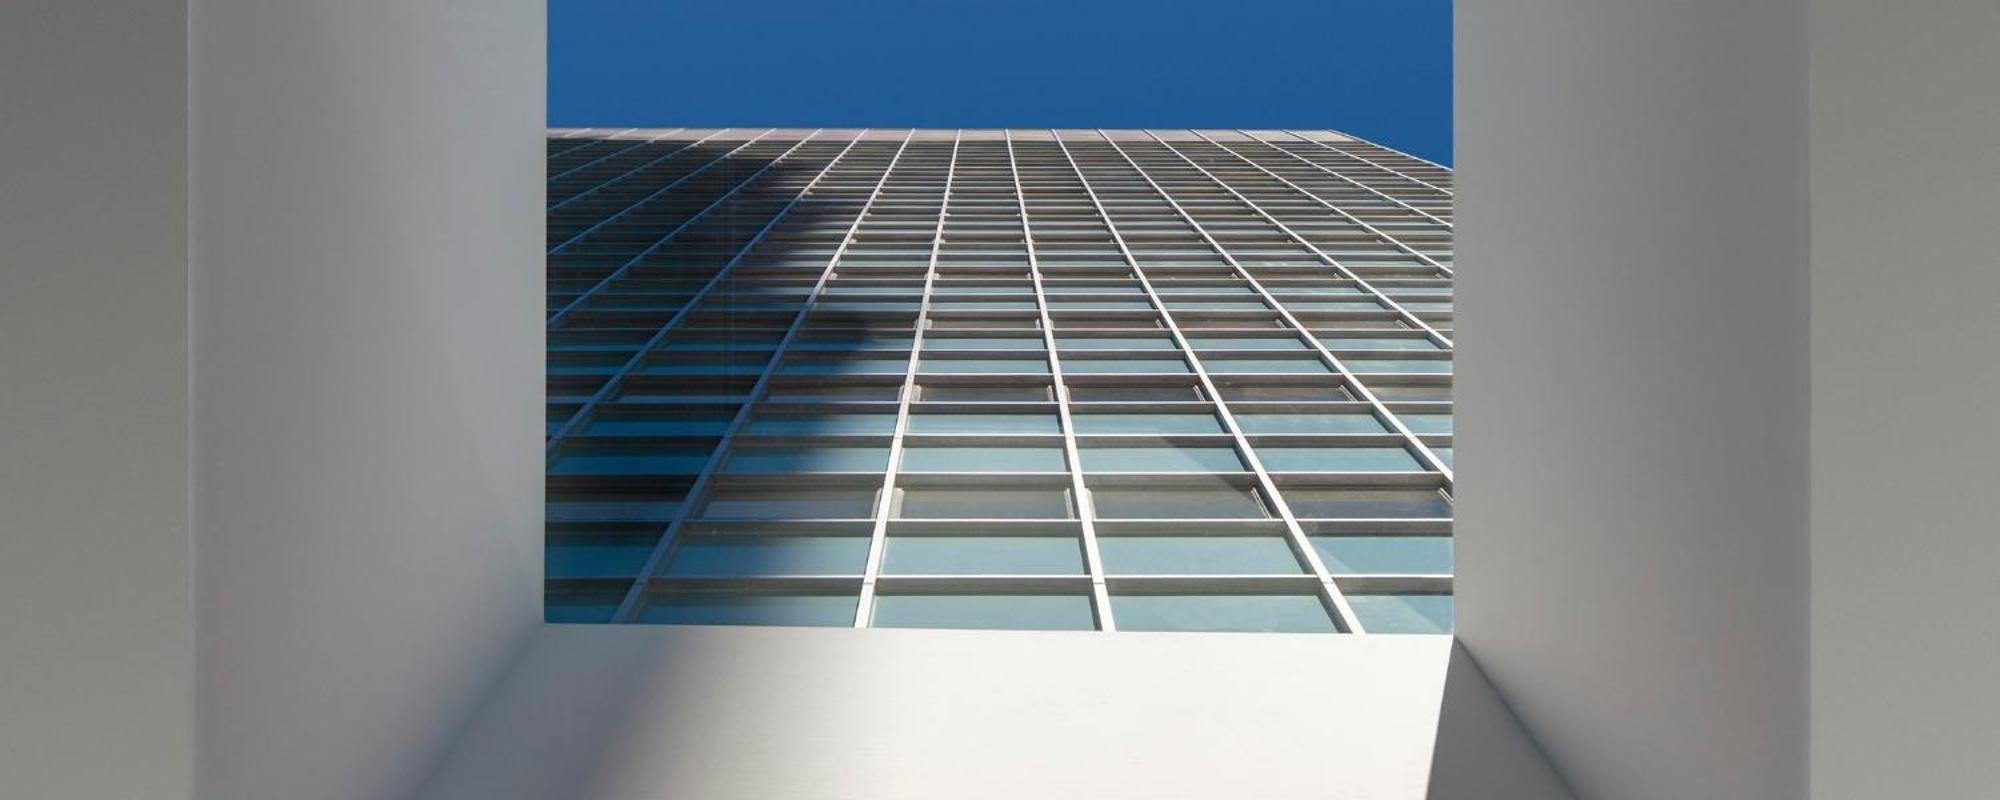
548, 0, 1452, 164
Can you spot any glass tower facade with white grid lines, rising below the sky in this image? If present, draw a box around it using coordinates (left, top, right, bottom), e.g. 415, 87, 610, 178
548, 128, 1452, 632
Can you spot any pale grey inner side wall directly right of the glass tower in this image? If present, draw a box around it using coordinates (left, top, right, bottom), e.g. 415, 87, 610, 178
1456, 0, 1808, 800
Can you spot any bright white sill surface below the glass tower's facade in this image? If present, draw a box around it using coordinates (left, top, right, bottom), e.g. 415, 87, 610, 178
422, 626, 1452, 800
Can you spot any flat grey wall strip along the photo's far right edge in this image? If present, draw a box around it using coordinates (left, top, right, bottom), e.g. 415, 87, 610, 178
1810, 0, 2000, 800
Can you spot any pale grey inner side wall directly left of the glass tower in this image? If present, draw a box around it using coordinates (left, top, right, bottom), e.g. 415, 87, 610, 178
190, 0, 544, 800
